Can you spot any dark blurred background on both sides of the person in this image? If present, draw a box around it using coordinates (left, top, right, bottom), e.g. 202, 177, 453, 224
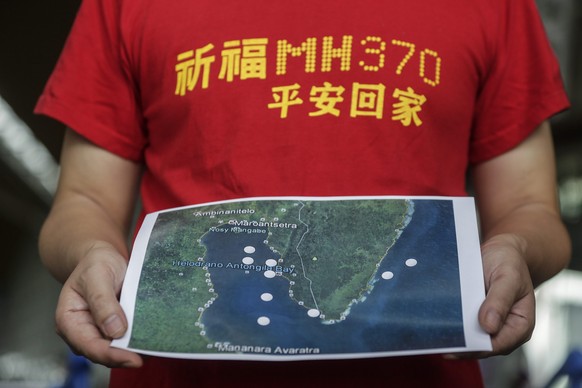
0, 0, 582, 388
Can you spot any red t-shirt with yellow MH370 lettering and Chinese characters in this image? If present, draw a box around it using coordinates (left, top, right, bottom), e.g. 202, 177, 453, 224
37, 0, 568, 387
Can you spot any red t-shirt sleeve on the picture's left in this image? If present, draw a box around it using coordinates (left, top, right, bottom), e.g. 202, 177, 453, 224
35, 0, 145, 161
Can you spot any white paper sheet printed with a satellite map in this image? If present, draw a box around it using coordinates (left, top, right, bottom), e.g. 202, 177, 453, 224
112, 196, 491, 361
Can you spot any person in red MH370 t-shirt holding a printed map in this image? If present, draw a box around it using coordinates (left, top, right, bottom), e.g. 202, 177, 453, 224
36, 0, 570, 387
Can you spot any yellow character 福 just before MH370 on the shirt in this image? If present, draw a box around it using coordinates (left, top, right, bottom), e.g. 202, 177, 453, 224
218, 38, 269, 82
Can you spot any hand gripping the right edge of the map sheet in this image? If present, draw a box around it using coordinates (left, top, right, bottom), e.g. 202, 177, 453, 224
479, 234, 535, 356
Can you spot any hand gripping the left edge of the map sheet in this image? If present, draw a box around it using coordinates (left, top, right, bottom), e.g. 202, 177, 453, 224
56, 243, 142, 368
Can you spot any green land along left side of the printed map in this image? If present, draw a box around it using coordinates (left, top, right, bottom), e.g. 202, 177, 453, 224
130, 212, 214, 352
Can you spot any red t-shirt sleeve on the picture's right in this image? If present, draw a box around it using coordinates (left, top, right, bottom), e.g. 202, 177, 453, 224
470, 0, 569, 164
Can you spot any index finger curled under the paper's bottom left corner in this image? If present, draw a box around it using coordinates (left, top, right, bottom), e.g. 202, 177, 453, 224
56, 288, 142, 367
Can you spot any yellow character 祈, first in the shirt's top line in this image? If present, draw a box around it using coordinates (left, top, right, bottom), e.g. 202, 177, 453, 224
175, 44, 215, 96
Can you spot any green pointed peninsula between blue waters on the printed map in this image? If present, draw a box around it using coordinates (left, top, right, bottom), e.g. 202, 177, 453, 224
285, 200, 407, 319
